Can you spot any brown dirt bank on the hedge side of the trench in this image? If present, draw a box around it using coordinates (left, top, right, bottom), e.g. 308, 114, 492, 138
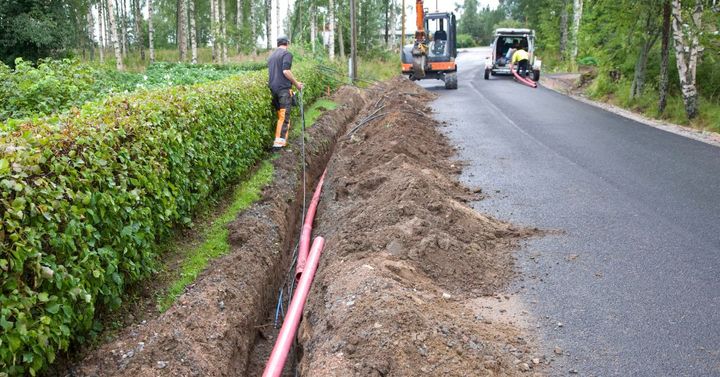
69, 88, 365, 377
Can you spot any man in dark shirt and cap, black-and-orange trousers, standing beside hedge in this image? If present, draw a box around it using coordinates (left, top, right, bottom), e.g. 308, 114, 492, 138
268, 36, 303, 150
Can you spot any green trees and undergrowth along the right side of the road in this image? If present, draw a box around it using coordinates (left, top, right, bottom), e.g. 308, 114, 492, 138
460, 0, 720, 132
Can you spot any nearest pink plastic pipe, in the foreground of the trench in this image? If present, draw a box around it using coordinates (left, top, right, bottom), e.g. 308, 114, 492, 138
263, 237, 325, 377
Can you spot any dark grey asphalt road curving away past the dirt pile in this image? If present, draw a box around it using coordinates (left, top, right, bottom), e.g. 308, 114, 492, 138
421, 49, 720, 376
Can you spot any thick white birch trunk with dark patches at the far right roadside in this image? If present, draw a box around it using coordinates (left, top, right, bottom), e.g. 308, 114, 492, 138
672, 0, 703, 119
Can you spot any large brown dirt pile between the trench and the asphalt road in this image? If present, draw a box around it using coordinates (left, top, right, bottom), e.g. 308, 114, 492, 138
299, 79, 537, 376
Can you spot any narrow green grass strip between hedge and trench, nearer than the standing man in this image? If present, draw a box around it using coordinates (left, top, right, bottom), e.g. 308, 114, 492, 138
158, 160, 274, 312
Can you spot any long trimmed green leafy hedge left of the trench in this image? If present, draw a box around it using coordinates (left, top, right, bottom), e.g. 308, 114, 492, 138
0, 64, 331, 375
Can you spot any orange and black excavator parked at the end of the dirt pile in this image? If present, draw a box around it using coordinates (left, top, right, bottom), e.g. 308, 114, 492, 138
402, 0, 457, 89
